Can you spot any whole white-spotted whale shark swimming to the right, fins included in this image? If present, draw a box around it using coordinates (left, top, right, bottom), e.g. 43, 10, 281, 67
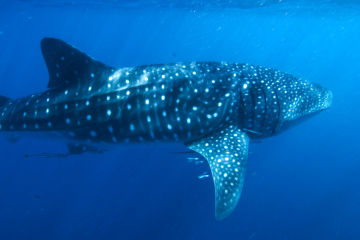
0, 38, 332, 220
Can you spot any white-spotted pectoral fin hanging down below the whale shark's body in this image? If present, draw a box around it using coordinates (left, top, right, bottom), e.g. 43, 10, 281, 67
187, 126, 249, 220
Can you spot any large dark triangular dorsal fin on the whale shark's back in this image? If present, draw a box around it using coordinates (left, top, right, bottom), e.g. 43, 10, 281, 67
41, 38, 113, 88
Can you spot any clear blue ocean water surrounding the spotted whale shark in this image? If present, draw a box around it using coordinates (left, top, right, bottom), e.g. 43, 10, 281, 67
0, 0, 360, 240
